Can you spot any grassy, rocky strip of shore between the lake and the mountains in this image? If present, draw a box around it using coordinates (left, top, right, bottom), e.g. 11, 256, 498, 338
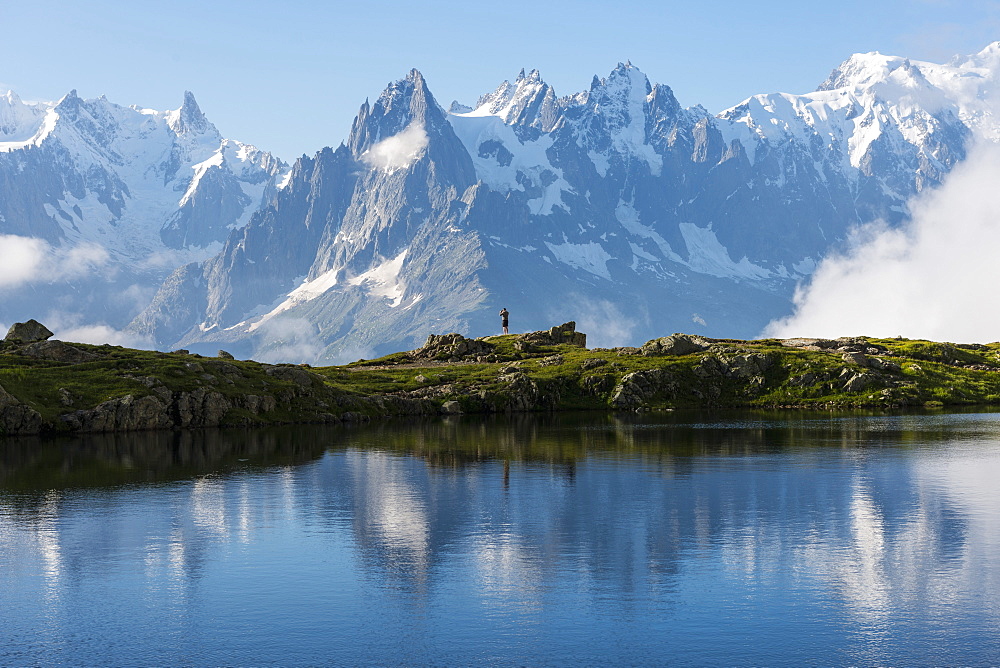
0, 323, 1000, 435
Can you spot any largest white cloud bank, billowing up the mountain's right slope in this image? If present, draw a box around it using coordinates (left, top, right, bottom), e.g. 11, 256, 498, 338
763, 141, 1000, 342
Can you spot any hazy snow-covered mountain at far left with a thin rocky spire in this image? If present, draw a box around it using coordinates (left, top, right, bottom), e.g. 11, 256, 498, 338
0, 91, 288, 340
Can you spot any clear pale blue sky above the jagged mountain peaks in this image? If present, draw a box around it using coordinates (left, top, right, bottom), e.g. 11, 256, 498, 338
0, 0, 1000, 160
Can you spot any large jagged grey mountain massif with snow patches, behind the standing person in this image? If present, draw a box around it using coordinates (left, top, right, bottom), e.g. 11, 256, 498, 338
131, 44, 1000, 361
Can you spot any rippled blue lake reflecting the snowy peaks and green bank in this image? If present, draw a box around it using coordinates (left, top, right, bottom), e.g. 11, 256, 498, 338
0, 413, 1000, 665
